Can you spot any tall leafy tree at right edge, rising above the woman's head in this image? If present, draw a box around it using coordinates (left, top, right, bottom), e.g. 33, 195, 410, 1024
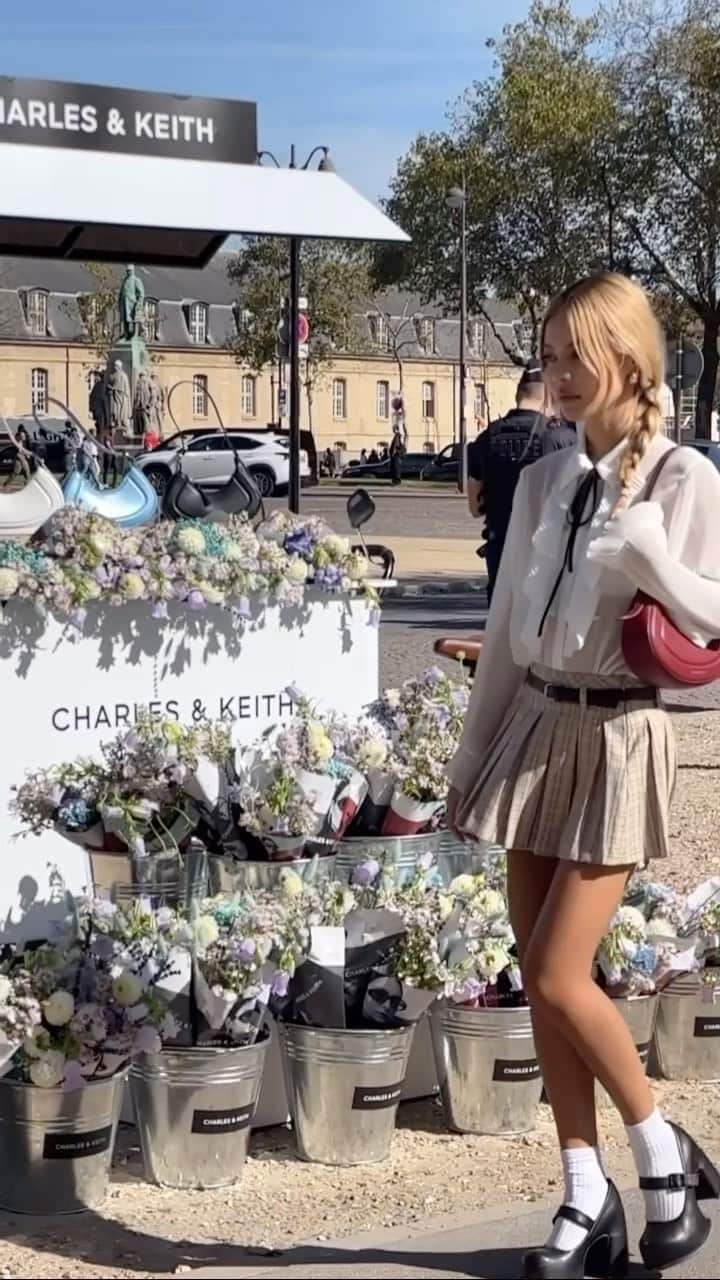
606, 0, 720, 436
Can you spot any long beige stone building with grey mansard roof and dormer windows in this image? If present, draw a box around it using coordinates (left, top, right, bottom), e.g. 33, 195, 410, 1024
0, 255, 523, 456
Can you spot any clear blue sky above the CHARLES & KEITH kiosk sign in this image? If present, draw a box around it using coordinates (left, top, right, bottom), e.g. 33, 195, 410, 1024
0, 0, 592, 200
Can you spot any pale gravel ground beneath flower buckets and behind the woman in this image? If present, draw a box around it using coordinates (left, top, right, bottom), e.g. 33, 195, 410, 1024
0, 714, 720, 1280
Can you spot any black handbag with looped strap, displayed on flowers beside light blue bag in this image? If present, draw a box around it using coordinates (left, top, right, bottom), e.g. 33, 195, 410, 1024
163, 379, 265, 522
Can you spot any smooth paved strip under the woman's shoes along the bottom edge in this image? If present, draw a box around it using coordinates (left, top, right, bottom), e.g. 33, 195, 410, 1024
189, 1192, 720, 1280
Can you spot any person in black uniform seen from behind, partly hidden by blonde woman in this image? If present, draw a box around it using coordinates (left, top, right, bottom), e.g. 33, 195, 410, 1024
468, 364, 577, 605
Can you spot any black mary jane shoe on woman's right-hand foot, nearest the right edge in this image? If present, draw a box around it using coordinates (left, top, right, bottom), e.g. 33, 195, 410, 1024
641, 1124, 720, 1271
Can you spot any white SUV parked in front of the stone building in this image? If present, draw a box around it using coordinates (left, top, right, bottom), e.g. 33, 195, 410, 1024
135, 429, 310, 498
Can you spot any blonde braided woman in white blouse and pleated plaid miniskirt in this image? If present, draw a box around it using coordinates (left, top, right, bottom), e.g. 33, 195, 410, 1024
450, 275, 720, 1277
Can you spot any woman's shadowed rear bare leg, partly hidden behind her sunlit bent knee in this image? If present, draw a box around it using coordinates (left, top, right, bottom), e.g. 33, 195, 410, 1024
507, 849, 597, 1148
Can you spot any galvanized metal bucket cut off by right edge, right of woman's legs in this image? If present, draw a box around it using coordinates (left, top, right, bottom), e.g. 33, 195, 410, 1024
655, 970, 720, 1082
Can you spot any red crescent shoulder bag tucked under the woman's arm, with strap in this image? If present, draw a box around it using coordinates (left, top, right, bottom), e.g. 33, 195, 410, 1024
623, 449, 720, 689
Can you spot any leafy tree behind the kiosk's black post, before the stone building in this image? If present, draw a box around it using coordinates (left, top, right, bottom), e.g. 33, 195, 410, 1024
228, 237, 369, 426
